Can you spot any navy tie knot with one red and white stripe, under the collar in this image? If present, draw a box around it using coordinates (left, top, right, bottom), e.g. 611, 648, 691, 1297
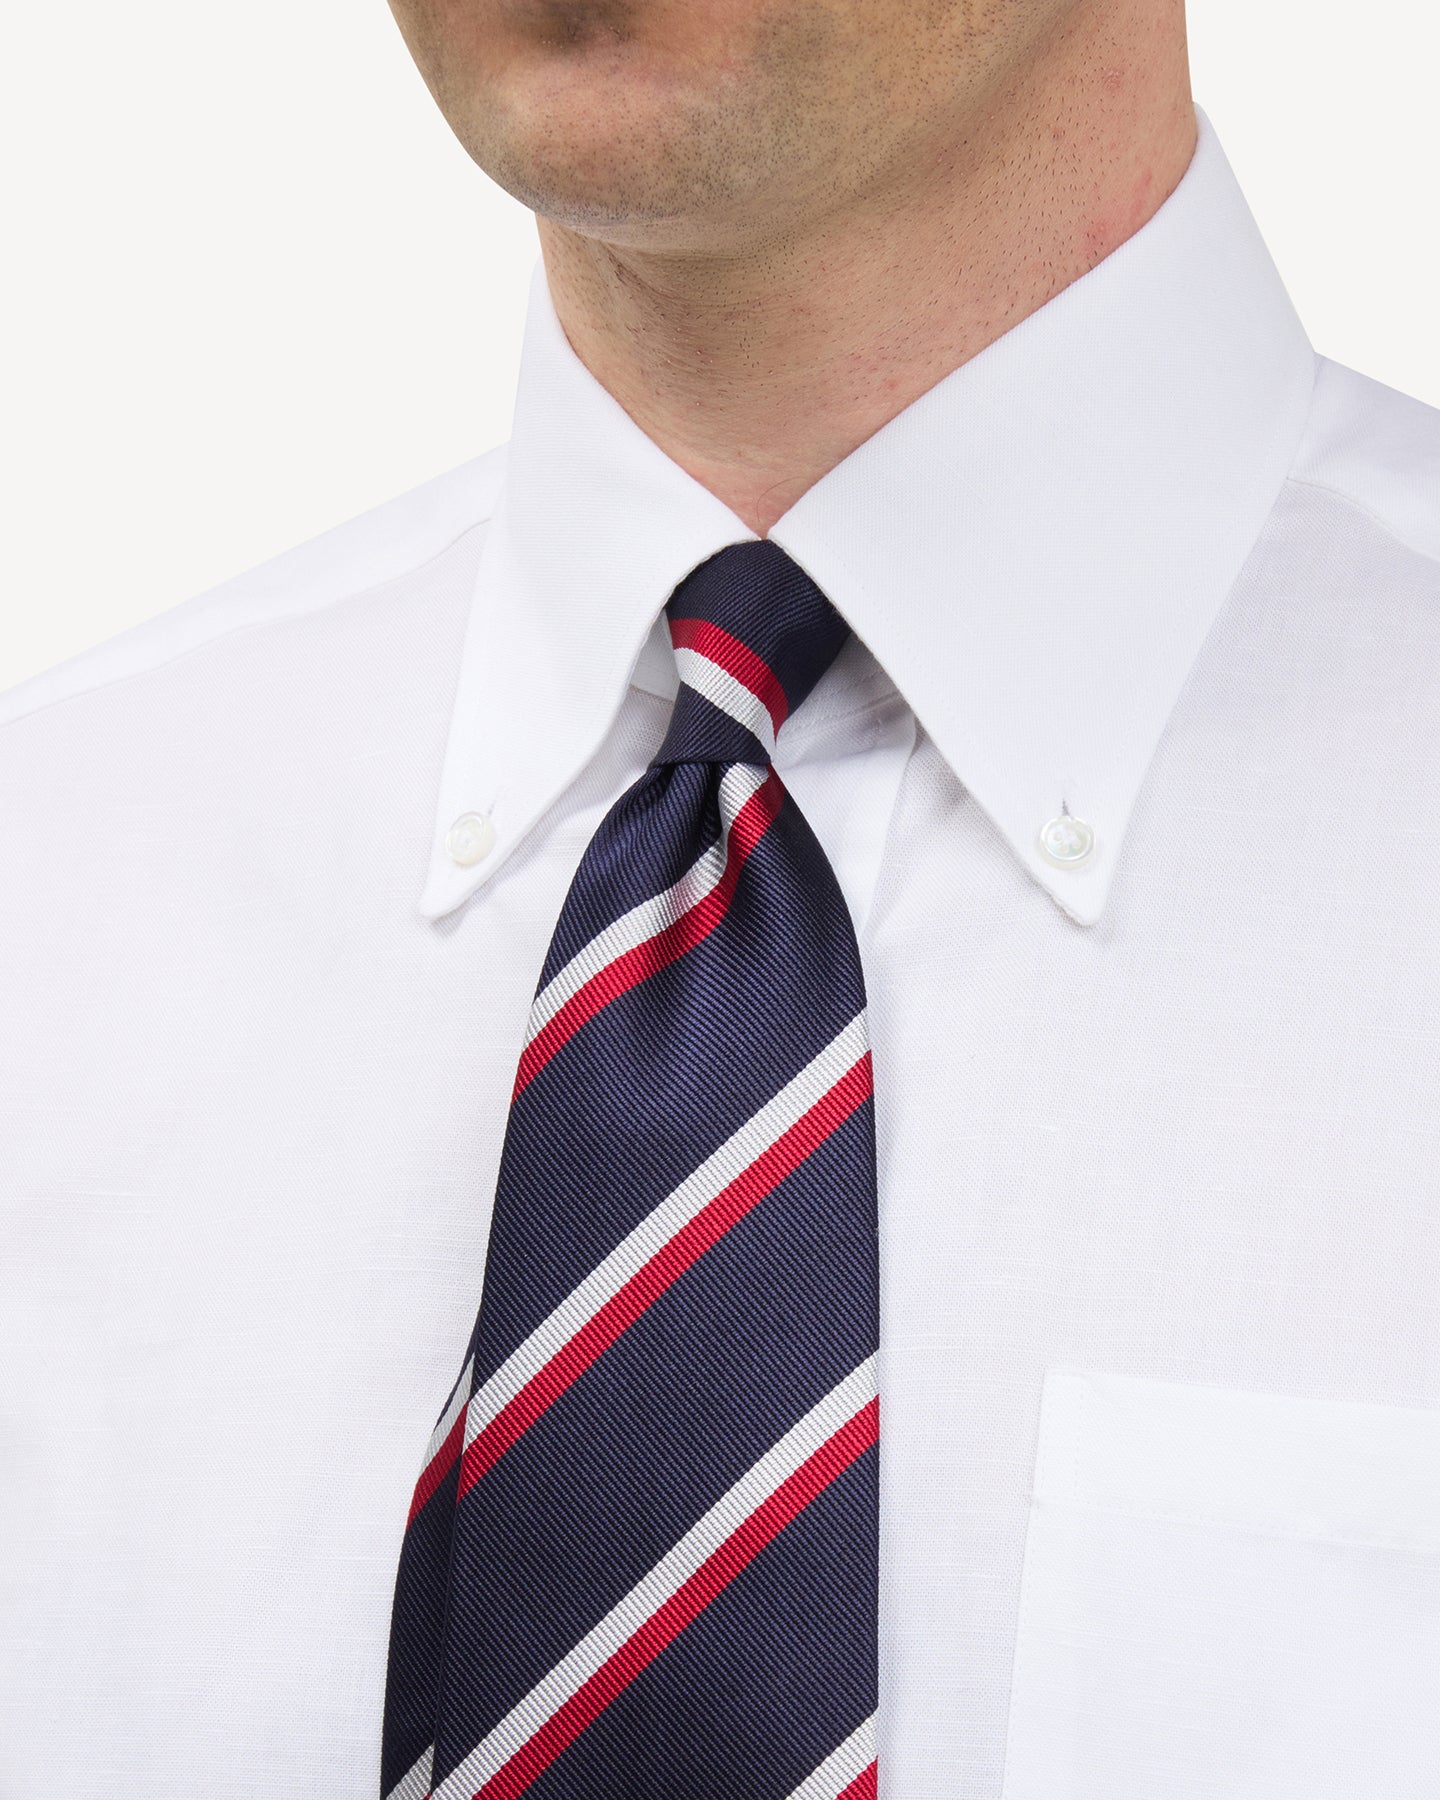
655, 538, 850, 763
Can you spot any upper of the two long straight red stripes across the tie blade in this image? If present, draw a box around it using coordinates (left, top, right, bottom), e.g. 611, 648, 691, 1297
455, 1051, 873, 1499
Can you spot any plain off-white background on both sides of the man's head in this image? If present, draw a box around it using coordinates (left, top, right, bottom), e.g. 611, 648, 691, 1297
0, 0, 1440, 689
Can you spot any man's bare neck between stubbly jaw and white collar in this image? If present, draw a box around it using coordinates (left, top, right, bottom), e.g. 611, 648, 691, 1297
540, 0, 1195, 536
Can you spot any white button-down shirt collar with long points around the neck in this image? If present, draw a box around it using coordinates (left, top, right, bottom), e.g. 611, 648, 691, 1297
421, 115, 1314, 923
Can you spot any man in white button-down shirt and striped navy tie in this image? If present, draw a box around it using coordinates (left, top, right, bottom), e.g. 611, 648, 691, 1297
0, 0, 1440, 1800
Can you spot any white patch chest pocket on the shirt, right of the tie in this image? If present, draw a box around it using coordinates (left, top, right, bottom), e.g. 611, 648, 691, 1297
1004, 1370, 1440, 1800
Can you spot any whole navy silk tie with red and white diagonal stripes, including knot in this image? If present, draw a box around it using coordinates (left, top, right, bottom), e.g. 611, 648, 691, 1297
382, 540, 878, 1800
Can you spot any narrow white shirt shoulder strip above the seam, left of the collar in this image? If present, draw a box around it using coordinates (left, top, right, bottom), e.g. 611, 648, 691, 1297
0, 445, 506, 727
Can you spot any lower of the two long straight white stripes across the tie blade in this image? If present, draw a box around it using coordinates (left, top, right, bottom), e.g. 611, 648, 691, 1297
434, 1355, 877, 1800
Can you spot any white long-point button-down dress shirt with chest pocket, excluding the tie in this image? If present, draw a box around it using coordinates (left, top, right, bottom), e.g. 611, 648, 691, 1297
0, 112, 1440, 1800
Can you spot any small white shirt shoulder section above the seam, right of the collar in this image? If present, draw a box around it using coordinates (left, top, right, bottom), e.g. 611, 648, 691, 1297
1291, 358, 1440, 562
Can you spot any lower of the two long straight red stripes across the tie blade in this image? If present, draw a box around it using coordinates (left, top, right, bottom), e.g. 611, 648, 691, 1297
473, 1400, 880, 1800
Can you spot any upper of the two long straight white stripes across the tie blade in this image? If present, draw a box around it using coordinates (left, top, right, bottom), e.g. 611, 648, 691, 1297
464, 1013, 868, 1449
